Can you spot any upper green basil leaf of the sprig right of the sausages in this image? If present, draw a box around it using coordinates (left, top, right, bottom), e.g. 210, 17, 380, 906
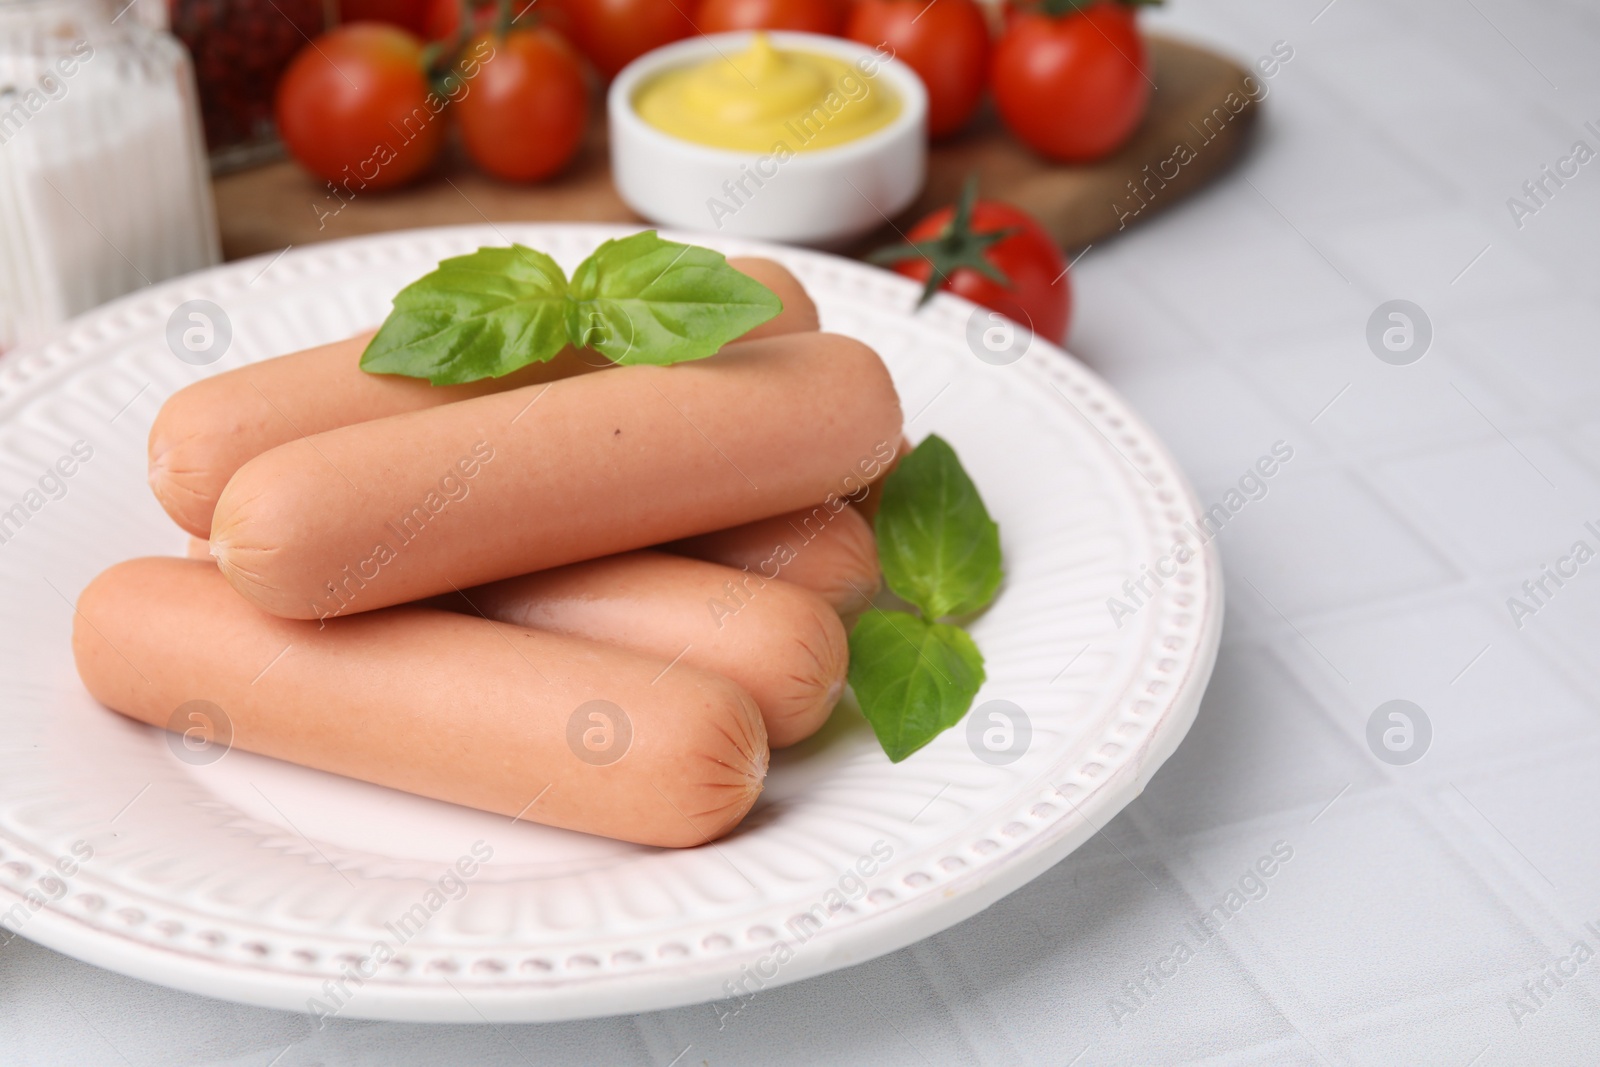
874, 435, 1003, 619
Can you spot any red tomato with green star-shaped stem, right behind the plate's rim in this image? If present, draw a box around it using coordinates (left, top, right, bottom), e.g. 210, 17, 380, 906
870, 182, 1072, 342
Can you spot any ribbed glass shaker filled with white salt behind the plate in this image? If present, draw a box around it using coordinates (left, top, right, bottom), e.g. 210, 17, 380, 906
0, 0, 219, 350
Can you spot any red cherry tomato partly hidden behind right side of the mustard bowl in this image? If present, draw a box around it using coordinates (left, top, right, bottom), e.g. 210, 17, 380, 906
845, 0, 989, 138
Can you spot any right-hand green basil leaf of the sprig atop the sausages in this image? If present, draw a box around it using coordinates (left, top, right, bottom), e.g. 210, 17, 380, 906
566, 230, 784, 365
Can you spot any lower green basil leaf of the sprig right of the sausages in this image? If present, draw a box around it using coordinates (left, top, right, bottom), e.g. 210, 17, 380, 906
850, 609, 984, 763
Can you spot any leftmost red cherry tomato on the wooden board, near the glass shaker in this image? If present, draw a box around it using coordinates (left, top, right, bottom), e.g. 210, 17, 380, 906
274, 22, 445, 190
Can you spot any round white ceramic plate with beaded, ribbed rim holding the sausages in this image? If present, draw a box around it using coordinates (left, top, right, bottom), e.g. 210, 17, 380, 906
0, 224, 1222, 1022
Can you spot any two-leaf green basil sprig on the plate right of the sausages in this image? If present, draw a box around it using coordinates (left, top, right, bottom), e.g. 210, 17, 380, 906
850, 435, 1003, 763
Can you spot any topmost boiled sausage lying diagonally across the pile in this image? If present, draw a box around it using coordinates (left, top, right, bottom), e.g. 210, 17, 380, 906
211, 333, 901, 619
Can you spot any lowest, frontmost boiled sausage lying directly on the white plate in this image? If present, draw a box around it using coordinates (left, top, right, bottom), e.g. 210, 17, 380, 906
72, 558, 766, 846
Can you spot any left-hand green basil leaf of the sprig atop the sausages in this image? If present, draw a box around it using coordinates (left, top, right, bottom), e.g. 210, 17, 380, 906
362, 245, 568, 386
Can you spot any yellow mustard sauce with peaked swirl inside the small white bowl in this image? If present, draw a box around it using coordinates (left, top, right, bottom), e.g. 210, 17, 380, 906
634, 34, 901, 155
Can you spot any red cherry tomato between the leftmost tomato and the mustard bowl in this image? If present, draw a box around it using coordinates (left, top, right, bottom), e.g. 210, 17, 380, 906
454, 27, 589, 181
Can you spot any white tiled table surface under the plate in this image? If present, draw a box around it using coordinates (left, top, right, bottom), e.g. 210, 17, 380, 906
0, 0, 1600, 1067
